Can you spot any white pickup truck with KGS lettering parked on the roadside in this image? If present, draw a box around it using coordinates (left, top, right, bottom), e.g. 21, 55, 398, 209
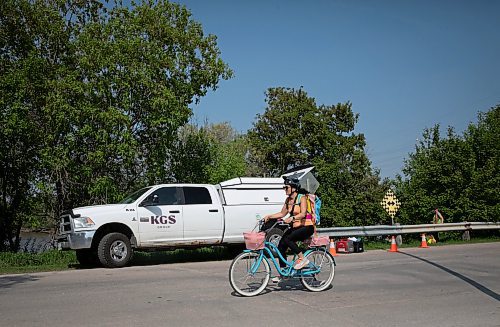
58, 177, 286, 268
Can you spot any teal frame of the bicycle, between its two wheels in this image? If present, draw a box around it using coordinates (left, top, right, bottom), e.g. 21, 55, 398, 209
244, 242, 335, 277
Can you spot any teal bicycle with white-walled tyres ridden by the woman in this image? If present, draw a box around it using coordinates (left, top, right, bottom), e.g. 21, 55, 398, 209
229, 231, 335, 296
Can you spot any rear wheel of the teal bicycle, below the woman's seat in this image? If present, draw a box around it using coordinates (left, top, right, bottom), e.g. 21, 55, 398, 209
300, 250, 335, 292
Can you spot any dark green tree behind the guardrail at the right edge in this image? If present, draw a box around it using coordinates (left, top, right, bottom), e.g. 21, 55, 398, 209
396, 106, 500, 224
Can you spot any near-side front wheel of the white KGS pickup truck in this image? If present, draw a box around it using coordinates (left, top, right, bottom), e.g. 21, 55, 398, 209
97, 233, 133, 268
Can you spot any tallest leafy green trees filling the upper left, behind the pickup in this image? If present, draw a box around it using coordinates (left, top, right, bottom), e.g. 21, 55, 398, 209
0, 0, 232, 251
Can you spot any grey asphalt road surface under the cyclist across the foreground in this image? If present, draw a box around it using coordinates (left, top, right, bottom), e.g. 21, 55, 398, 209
0, 243, 500, 327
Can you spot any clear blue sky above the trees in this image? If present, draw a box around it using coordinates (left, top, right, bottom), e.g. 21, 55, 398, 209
170, 0, 500, 177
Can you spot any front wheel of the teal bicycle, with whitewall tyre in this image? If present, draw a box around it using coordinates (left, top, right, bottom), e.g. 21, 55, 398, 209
229, 252, 271, 296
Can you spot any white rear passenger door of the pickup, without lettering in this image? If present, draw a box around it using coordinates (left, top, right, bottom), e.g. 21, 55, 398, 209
182, 186, 224, 244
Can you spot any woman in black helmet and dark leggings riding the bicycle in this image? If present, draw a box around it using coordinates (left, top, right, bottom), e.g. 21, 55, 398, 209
264, 178, 314, 282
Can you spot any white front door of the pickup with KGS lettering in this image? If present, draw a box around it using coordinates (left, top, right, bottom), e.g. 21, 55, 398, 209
137, 186, 184, 245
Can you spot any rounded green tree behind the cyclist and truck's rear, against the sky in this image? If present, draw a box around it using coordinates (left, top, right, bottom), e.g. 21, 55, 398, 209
248, 88, 384, 226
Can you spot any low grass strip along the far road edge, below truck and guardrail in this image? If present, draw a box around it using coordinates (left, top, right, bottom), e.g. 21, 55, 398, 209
0, 233, 500, 275
